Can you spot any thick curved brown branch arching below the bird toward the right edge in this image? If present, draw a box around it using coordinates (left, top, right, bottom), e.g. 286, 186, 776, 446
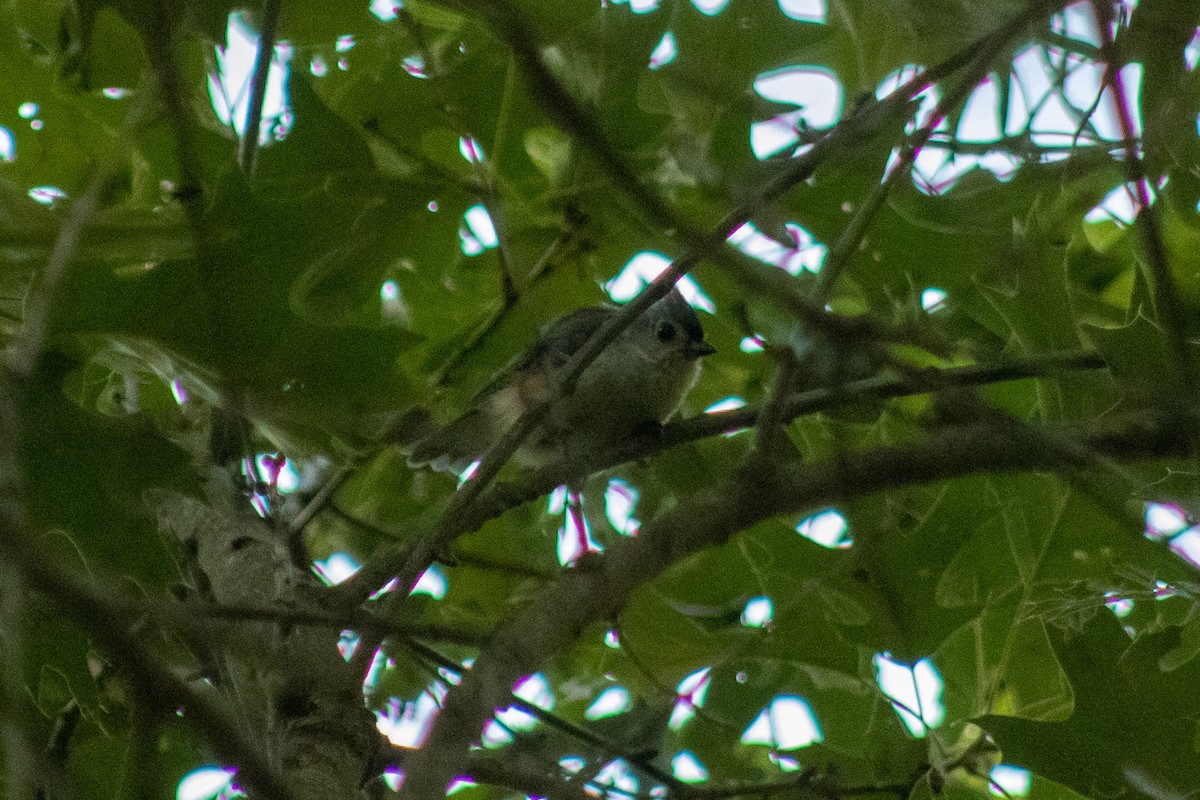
403, 398, 1176, 800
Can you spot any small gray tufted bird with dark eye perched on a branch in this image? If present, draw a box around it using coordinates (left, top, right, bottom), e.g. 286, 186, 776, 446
409, 289, 714, 473
